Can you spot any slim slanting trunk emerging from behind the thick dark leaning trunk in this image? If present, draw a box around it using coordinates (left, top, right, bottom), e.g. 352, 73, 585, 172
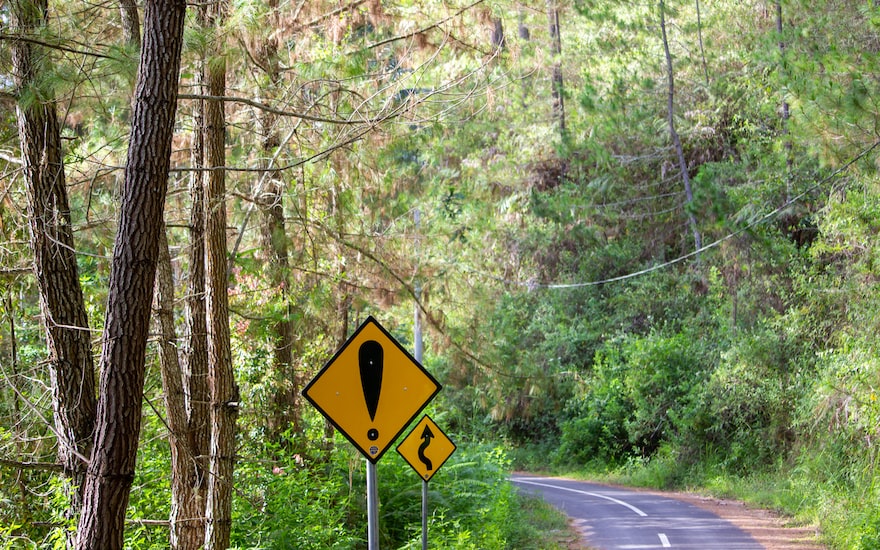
155, 228, 205, 550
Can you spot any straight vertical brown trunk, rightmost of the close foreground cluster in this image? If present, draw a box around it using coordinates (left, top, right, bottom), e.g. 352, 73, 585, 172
205, 1, 238, 550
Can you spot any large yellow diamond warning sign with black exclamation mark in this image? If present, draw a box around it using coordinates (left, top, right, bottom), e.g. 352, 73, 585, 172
303, 316, 441, 464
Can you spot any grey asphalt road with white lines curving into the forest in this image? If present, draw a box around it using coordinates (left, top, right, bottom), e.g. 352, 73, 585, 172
511, 476, 763, 550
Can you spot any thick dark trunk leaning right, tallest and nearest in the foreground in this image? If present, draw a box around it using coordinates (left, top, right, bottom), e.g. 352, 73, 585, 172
77, 0, 186, 550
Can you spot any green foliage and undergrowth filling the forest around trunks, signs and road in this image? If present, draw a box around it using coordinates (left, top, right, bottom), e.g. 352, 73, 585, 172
8, 0, 880, 549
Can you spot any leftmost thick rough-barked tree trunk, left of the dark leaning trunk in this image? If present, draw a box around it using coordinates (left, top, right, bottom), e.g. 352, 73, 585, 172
12, 0, 96, 536
